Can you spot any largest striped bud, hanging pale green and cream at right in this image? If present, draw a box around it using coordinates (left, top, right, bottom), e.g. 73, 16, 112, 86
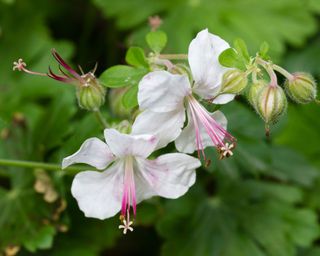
255, 85, 287, 125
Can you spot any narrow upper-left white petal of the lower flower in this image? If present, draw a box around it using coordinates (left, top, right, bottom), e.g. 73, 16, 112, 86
62, 138, 114, 170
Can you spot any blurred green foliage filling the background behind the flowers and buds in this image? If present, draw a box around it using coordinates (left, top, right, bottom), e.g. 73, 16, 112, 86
0, 0, 320, 256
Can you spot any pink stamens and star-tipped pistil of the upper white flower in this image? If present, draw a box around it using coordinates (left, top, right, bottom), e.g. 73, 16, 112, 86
187, 95, 236, 164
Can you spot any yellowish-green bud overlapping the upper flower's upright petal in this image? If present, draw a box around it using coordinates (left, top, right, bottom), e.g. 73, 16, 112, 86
221, 69, 248, 94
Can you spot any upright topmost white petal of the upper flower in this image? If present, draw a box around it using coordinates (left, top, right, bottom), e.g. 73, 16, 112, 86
188, 29, 230, 99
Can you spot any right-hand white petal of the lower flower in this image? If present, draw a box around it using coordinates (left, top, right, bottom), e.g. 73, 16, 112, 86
136, 153, 201, 200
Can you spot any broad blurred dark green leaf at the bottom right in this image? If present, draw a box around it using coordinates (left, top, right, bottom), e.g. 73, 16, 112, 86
157, 181, 319, 256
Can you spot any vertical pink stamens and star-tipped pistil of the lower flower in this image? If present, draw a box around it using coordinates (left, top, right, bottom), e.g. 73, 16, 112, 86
119, 156, 137, 234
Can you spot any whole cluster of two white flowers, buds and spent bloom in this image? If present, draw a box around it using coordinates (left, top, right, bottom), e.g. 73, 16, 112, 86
14, 29, 316, 234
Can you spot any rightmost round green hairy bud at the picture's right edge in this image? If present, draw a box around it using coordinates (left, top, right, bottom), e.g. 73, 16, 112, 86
284, 73, 317, 104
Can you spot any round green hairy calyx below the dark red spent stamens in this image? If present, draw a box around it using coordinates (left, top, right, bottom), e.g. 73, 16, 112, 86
77, 78, 106, 111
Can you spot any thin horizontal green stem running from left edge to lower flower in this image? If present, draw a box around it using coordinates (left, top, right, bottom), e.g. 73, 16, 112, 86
0, 159, 84, 174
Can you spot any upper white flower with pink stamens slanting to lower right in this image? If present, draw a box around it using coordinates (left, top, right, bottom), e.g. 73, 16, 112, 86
132, 29, 235, 158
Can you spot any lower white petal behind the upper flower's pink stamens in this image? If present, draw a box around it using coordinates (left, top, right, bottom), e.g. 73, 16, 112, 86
175, 111, 227, 154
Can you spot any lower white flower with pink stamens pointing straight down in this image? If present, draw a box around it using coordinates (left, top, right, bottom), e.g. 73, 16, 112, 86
62, 129, 200, 234
